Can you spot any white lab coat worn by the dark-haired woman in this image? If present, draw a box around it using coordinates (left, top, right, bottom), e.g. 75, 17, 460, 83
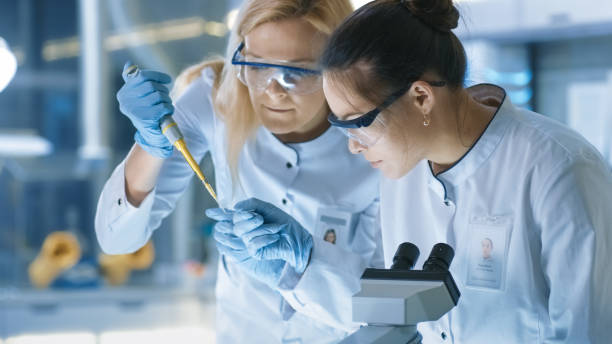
381, 85, 612, 344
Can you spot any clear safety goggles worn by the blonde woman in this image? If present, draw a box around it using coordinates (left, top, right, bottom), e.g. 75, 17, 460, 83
232, 42, 323, 94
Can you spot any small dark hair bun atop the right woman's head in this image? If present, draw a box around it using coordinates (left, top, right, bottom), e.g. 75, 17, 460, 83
400, 0, 459, 32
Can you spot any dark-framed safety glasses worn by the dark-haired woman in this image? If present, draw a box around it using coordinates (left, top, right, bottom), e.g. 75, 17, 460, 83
327, 81, 446, 147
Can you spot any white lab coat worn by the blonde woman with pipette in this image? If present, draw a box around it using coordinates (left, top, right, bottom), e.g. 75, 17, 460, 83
95, 70, 383, 343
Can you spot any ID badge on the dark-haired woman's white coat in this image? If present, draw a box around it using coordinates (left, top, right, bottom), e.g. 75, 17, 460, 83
466, 216, 512, 290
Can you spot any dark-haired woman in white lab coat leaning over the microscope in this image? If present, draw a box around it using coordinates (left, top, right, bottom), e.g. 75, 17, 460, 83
322, 0, 612, 343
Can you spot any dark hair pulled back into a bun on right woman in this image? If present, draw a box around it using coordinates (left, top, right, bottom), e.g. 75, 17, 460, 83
321, 0, 466, 103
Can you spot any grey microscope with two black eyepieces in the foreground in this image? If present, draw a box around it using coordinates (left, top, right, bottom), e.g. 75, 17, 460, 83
341, 242, 460, 344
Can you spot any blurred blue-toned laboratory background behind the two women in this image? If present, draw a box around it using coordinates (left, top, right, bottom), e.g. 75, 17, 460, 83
0, 0, 612, 344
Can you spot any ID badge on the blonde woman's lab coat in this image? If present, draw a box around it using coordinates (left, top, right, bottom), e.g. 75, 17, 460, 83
315, 207, 355, 247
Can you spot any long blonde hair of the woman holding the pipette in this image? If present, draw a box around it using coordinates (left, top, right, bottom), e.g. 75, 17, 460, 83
172, 0, 353, 180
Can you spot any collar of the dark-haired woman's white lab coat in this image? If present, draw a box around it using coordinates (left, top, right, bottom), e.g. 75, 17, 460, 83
436, 84, 514, 189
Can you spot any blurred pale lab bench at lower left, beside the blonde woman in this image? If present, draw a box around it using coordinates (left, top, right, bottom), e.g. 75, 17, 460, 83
0, 287, 215, 338
